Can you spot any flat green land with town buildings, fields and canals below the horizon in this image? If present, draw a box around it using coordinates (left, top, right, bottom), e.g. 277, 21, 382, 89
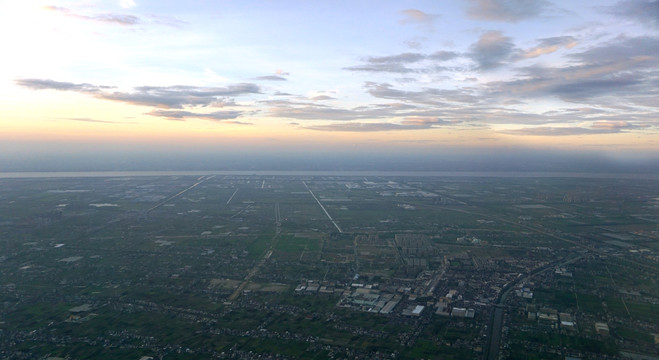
0, 173, 659, 360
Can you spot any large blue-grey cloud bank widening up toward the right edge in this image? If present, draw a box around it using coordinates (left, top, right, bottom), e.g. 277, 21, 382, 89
486, 36, 659, 102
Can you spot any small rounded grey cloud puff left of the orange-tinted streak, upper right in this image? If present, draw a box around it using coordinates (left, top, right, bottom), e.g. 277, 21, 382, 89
468, 31, 515, 70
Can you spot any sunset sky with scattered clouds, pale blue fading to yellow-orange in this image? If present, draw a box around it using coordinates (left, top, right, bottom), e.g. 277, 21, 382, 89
0, 0, 659, 171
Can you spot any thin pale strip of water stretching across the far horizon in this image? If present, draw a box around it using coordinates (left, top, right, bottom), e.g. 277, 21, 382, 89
0, 170, 659, 180
